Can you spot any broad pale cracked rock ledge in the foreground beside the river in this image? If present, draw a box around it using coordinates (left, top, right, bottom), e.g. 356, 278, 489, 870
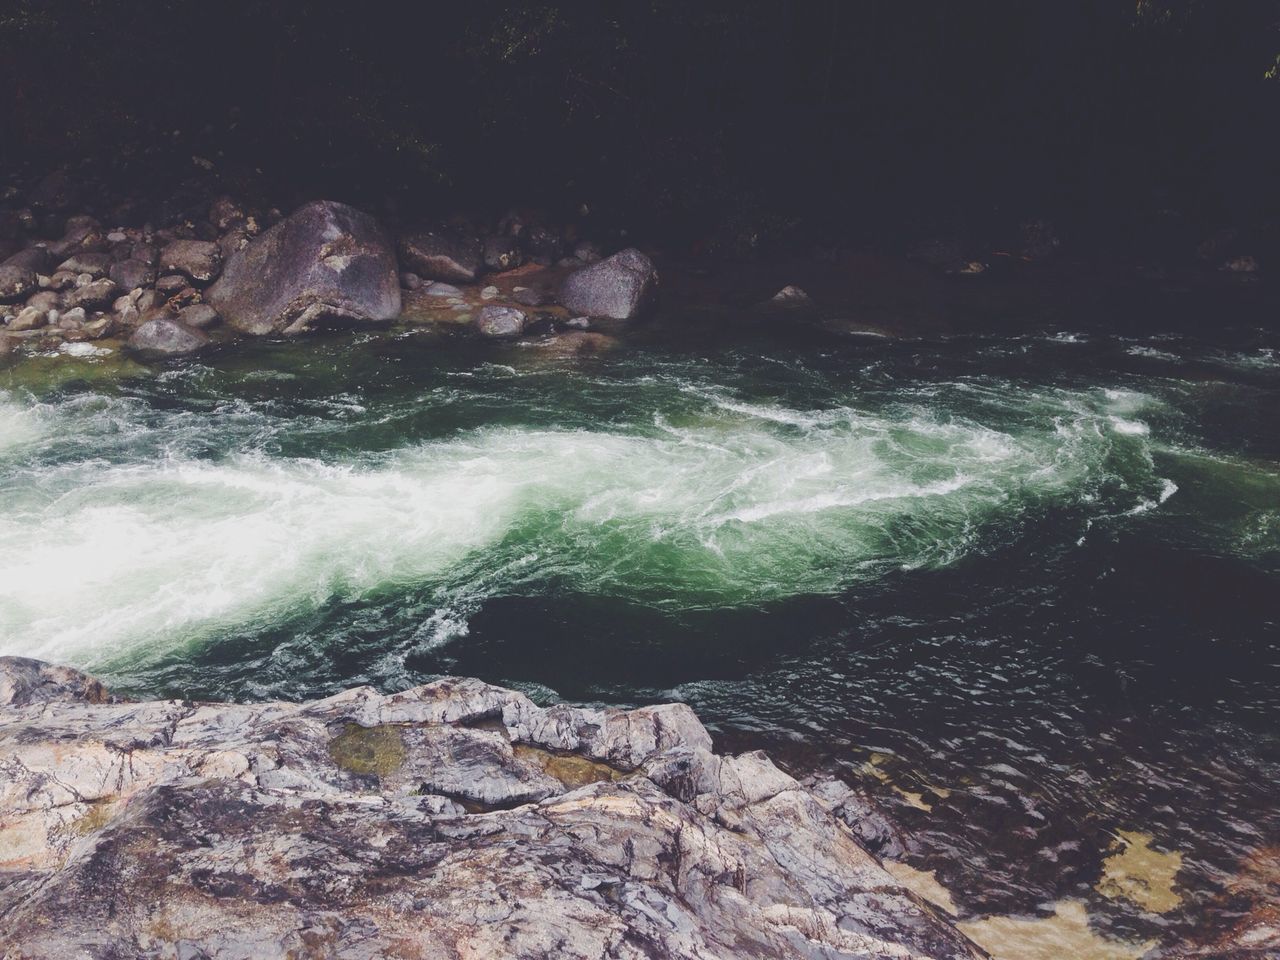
0, 658, 984, 960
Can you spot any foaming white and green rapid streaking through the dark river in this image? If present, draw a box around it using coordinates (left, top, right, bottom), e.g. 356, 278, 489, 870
0, 363, 1170, 667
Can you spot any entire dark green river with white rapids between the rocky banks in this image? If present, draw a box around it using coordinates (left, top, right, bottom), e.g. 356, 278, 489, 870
0, 321, 1280, 957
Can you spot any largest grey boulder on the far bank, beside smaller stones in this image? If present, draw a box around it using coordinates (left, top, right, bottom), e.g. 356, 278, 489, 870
205, 201, 401, 335
